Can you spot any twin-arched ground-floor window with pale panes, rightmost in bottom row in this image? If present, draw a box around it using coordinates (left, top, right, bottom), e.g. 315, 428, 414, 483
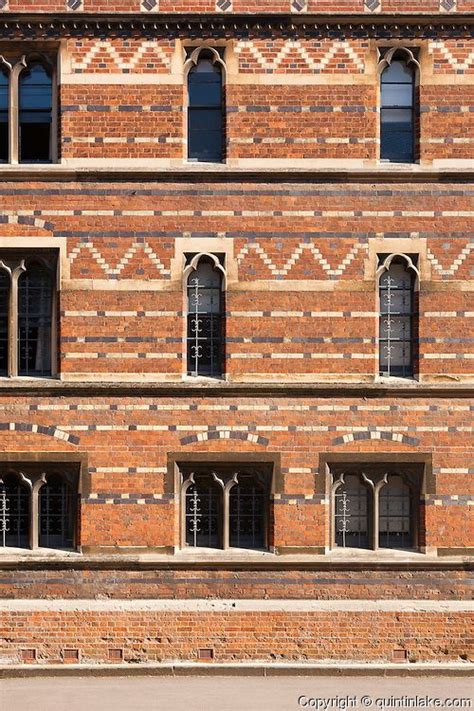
331, 467, 421, 550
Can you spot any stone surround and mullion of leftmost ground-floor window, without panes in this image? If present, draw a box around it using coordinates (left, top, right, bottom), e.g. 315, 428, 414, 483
0, 451, 88, 555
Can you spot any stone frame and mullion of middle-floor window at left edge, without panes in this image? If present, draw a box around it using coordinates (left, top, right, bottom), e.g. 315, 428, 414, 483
0, 253, 60, 379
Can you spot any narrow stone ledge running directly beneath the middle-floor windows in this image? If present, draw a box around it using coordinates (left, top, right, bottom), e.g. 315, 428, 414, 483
0, 380, 474, 399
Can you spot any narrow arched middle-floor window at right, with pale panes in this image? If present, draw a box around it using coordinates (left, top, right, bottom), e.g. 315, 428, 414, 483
379, 260, 414, 377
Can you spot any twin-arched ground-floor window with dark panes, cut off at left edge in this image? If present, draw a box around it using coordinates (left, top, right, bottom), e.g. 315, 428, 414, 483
0, 465, 78, 550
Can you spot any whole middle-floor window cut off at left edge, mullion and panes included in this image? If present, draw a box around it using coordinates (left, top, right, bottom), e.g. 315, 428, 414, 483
0, 250, 57, 377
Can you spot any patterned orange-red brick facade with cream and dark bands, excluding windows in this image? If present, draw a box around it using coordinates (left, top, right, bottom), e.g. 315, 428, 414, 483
0, 0, 474, 664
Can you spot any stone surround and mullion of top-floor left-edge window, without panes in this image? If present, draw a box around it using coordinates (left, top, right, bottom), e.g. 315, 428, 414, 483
0, 50, 59, 165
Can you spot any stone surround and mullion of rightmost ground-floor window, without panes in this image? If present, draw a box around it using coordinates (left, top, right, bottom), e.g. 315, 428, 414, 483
316, 452, 436, 556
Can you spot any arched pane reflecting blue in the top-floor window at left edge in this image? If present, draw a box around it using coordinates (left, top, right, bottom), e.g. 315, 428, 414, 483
19, 64, 53, 163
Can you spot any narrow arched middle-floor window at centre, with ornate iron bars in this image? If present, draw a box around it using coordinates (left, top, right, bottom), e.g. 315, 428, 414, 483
187, 260, 223, 376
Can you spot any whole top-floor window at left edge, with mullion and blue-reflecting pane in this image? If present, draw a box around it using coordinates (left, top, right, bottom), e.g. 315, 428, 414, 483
0, 51, 58, 164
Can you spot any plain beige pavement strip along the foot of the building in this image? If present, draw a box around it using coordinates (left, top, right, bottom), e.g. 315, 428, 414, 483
0, 676, 474, 711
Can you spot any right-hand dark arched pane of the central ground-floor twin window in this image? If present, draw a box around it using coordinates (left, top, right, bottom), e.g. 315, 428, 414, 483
229, 474, 267, 548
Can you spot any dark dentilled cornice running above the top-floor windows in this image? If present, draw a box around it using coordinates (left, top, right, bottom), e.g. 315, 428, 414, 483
0, 12, 474, 41
